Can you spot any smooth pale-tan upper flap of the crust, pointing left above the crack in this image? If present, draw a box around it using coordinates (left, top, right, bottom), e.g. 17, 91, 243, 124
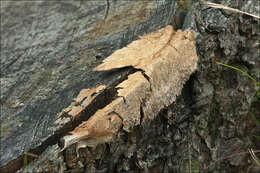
94, 26, 174, 71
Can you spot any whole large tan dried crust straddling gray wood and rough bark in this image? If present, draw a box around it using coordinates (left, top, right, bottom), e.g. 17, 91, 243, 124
59, 26, 198, 150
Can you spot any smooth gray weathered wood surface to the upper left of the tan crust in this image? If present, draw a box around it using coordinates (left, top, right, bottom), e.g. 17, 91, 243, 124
0, 1, 178, 172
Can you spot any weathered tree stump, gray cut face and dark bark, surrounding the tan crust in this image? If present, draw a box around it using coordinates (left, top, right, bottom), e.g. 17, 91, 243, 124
0, 0, 260, 173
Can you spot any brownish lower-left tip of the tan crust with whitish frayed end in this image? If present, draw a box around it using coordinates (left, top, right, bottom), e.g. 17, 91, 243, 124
60, 108, 122, 155
